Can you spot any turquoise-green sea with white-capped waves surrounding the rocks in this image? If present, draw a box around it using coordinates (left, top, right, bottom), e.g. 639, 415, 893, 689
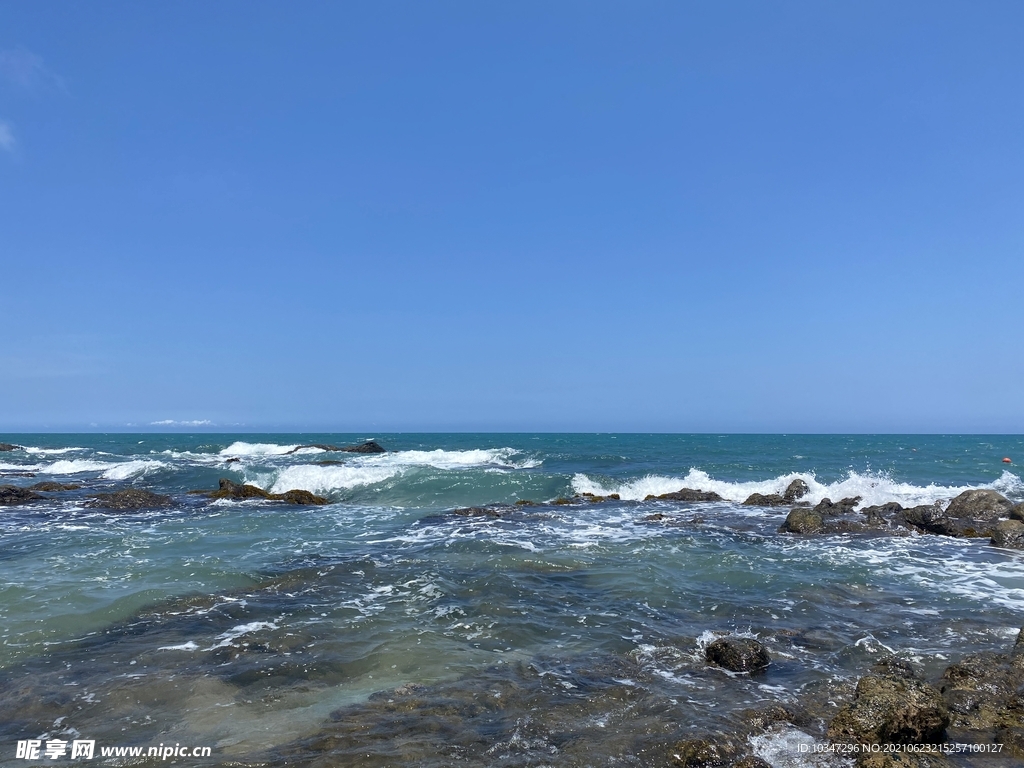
0, 433, 1024, 768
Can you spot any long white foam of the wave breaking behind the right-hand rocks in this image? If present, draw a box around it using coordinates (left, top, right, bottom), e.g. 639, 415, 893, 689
572, 469, 1024, 507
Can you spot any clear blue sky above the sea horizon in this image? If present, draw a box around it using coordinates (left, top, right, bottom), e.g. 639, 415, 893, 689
0, 0, 1024, 432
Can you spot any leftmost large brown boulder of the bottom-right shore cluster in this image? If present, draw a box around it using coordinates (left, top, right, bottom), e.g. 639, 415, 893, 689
828, 675, 949, 744
